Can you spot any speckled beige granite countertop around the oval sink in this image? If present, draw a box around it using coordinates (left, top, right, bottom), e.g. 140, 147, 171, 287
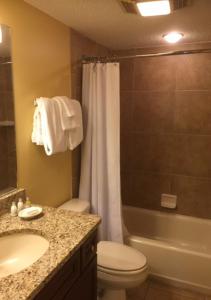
0, 208, 100, 300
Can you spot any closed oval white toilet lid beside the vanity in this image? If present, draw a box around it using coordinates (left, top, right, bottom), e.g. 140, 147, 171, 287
97, 241, 147, 271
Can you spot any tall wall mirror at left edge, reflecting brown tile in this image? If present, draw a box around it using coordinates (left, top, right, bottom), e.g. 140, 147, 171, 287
0, 25, 17, 194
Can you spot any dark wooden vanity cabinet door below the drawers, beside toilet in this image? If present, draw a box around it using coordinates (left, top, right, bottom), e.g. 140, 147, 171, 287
64, 256, 97, 300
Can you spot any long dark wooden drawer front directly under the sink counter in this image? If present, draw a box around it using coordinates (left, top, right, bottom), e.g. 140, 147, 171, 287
35, 251, 80, 300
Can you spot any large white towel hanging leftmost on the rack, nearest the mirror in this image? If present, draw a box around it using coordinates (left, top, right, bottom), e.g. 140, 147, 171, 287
32, 98, 68, 155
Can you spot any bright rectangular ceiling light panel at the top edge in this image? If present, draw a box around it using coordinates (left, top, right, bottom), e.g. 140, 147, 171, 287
136, 0, 171, 17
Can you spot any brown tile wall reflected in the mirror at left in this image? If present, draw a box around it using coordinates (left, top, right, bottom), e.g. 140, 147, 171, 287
0, 58, 17, 190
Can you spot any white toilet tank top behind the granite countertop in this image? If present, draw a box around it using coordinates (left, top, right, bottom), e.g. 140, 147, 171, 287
58, 198, 90, 214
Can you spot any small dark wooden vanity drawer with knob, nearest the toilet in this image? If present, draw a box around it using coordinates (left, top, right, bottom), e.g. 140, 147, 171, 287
81, 231, 97, 270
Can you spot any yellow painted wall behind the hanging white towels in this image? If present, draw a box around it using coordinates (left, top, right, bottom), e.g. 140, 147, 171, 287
0, 0, 71, 206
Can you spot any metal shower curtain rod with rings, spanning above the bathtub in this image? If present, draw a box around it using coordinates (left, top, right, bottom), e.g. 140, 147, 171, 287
82, 48, 211, 63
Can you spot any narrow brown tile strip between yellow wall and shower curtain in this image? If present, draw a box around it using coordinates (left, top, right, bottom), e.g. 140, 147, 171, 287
70, 29, 109, 197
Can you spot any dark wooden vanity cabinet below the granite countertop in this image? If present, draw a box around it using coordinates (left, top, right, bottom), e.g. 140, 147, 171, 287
34, 232, 97, 300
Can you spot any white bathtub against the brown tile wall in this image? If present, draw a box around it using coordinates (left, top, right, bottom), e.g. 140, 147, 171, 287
123, 206, 211, 294
